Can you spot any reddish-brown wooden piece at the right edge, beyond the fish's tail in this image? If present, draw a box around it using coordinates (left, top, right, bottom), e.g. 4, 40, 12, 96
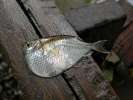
113, 23, 133, 67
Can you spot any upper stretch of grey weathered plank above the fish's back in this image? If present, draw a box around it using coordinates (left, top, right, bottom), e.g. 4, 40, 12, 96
23, 0, 76, 36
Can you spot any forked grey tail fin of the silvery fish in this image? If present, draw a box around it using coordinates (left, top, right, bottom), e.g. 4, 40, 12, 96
92, 40, 110, 54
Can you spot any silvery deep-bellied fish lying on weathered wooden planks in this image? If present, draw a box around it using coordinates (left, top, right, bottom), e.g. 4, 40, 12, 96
24, 35, 109, 77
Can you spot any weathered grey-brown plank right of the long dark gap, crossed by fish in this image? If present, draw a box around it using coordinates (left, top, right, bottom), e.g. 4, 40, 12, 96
21, 0, 117, 100
